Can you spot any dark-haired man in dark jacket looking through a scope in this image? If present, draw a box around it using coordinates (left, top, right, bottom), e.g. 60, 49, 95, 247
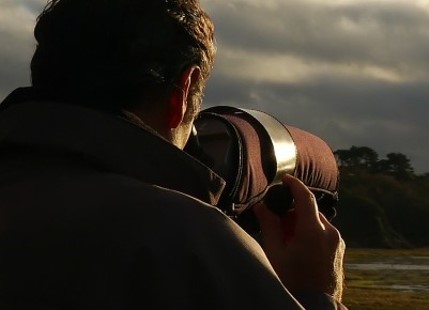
0, 0, 344, 310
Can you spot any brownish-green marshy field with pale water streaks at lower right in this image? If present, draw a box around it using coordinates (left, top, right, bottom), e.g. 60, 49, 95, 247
343, 248, 429, 310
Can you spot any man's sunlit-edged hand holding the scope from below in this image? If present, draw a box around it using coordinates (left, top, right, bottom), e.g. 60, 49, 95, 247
254, 175, 345, 301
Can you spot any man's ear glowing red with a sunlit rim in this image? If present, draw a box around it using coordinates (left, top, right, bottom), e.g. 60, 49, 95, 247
168, 66, 201, 128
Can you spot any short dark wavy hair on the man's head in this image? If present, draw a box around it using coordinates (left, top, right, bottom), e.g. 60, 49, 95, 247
31, 0, 216, 111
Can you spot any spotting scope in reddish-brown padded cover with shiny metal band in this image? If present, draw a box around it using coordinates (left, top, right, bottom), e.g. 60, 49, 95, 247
185, 106, 339, 232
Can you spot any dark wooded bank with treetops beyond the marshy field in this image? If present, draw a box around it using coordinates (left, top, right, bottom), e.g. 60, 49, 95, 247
333, 146, 429, 248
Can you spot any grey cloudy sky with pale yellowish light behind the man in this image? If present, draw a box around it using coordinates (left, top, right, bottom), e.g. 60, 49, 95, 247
0, 0, 429, 173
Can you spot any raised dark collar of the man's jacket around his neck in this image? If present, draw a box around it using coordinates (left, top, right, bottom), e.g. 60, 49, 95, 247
0, 88, 225, 205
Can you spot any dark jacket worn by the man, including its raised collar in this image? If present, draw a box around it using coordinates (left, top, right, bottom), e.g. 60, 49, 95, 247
0, 91, 342, 310
